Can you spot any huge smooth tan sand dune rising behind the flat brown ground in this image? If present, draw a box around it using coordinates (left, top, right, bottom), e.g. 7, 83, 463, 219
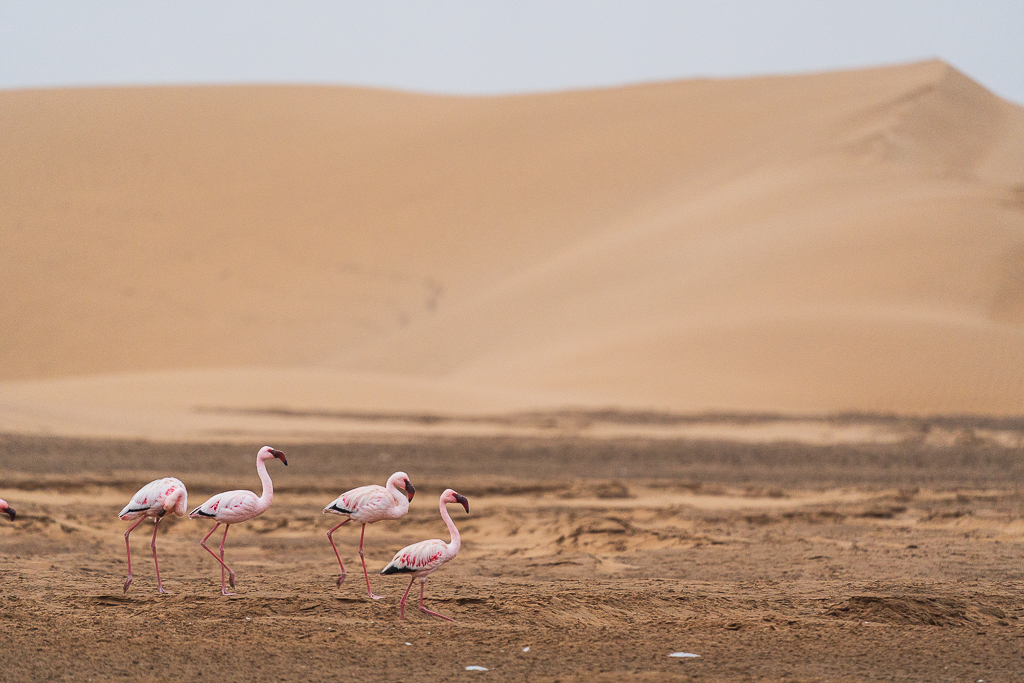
0, 61, 1024, 435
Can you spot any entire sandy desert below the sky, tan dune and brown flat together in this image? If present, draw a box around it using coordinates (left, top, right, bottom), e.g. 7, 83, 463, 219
0, 61, 1024, 683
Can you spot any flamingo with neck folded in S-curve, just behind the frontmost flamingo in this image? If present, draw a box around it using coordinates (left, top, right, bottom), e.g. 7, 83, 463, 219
324, 472, 416, 600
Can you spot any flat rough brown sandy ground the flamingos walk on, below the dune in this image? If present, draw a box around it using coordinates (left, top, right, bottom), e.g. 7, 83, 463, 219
0, 435, 1024, 682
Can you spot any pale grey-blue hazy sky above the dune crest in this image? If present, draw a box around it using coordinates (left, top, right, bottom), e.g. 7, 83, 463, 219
6, 0, 1024, 102
